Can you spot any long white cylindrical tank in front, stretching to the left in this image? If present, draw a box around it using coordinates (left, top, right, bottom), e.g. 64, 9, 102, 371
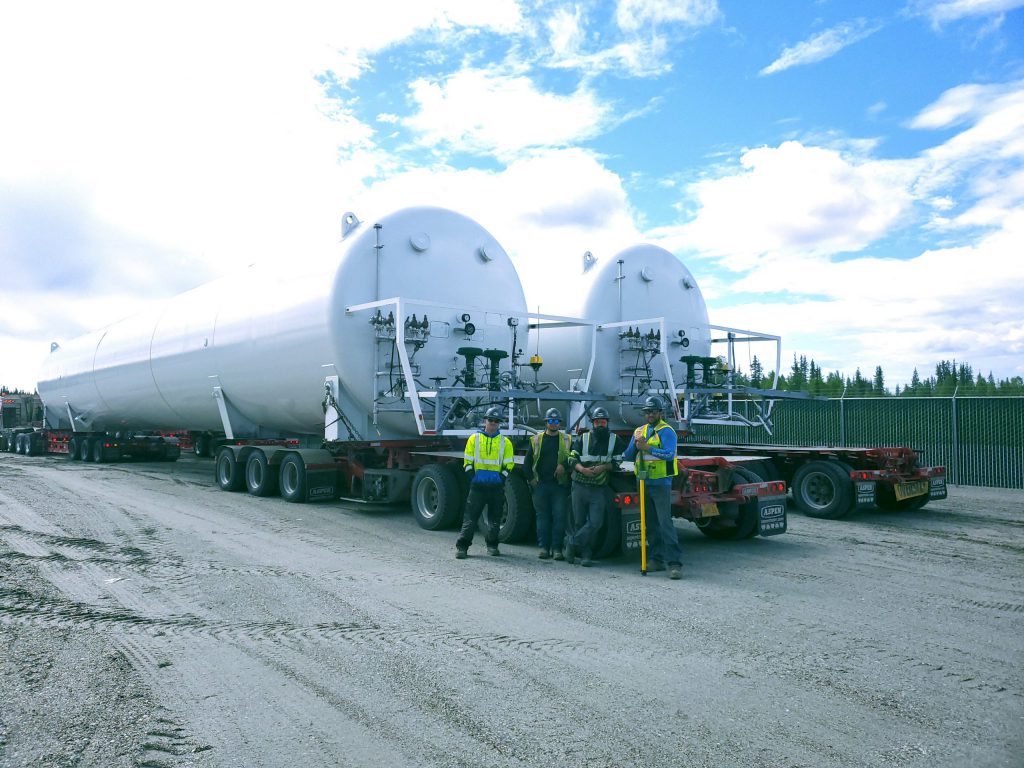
38, 208, 526, 438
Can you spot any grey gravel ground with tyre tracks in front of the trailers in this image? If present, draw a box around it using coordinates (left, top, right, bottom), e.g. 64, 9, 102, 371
0, 454, 1024, 768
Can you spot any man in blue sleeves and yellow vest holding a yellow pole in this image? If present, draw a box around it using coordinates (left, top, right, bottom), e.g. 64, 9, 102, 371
623, 397, 683, 579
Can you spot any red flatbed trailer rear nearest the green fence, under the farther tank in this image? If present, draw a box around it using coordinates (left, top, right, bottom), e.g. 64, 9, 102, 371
679, 442, 946, 519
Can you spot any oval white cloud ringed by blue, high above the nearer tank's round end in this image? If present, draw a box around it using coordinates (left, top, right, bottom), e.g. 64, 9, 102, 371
402, 69, 612, 158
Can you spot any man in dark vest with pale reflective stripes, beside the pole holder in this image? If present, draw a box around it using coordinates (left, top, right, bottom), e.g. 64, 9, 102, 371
565, 407, 617, 566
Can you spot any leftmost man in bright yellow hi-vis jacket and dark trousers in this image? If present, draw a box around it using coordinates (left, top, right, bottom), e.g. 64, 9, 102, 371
455, 406, 515, 560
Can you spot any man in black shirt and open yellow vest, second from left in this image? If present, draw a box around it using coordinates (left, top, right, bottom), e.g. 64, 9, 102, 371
523, 408, 571, 560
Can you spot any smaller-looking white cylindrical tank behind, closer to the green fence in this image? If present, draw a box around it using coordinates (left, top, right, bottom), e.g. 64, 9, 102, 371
524, 245, 711, 428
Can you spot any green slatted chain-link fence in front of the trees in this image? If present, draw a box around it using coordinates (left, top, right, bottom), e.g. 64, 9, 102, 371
694, 397, 1024, 488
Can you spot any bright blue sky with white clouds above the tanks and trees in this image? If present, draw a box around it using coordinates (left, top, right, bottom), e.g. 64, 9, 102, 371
0, 0, 1024, 387
